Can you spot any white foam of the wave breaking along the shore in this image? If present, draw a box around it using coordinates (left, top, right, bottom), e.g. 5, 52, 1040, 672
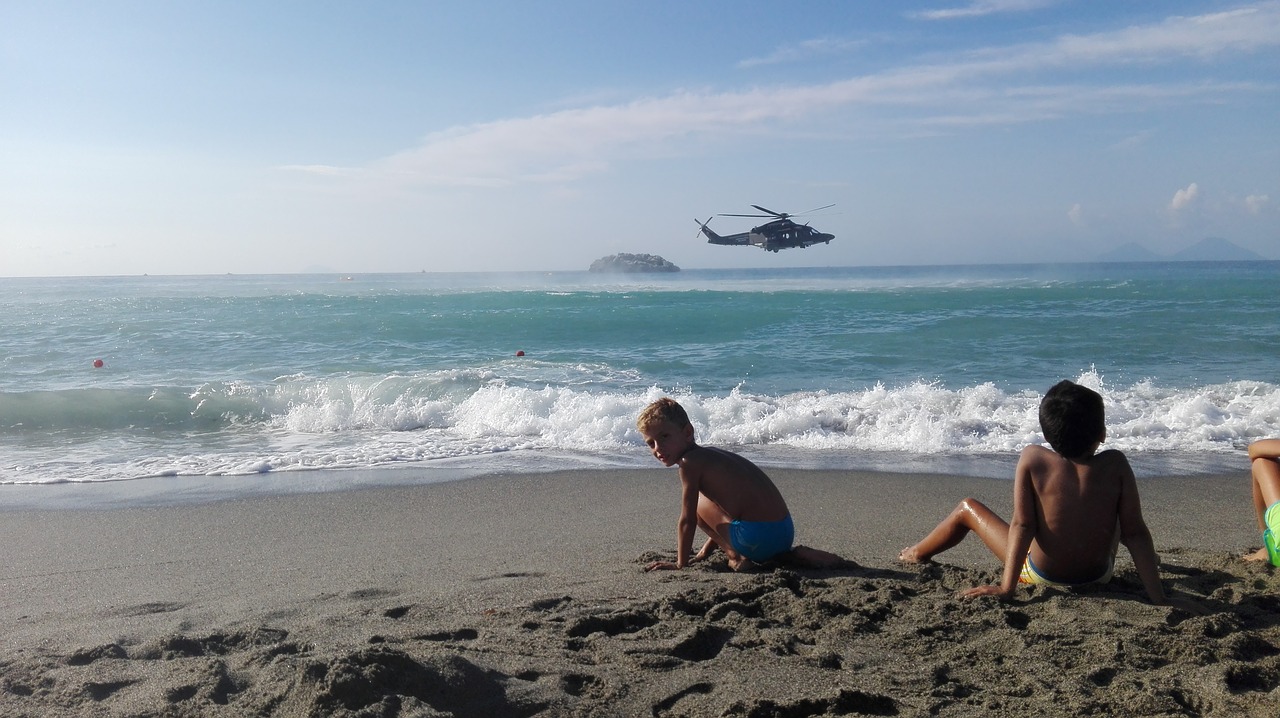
0, 371, 1280, 483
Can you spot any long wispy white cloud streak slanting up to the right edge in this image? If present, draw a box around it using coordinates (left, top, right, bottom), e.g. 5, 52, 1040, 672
293, 1, 1280, 190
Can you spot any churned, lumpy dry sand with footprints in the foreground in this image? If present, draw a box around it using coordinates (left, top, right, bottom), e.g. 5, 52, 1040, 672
0, 552, 1280, 718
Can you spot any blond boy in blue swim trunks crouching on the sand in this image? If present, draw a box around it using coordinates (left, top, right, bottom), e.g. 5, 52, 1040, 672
636, 397, 856, 571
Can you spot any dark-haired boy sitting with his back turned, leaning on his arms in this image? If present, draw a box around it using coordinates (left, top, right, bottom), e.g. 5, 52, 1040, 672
899, 381, 1167, 605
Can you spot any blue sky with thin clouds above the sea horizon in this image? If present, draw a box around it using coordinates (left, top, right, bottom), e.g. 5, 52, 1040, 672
0, 0, 1280, 276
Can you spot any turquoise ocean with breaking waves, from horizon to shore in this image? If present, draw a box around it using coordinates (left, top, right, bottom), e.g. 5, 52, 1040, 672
0, 262, 1280, 497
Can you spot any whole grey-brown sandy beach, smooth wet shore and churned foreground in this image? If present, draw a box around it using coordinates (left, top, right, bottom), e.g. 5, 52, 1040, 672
0, 468, 1280, 717
